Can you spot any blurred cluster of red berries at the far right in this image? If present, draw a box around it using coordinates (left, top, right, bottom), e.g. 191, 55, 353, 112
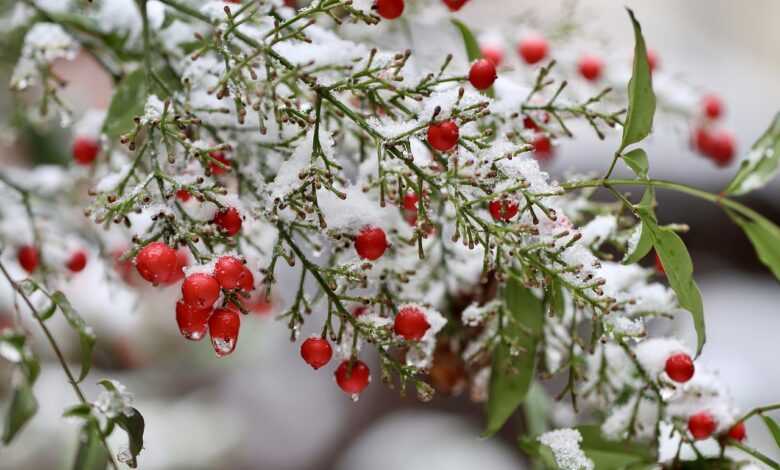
692, 95, 736, 167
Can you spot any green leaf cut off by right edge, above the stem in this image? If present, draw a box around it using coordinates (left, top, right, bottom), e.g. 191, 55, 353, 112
725, 113, 780, 195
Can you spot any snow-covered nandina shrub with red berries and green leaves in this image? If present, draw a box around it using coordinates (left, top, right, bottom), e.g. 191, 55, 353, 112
0, 0, 780, 469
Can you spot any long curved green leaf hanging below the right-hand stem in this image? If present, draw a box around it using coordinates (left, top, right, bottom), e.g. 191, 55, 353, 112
640, 210, 707, 356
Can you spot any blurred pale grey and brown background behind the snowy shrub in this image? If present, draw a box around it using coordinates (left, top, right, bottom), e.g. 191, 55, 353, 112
0, 0, 780, 470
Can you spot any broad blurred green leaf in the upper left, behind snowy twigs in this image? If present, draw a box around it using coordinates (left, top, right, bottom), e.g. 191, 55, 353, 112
103, 69, 147, 139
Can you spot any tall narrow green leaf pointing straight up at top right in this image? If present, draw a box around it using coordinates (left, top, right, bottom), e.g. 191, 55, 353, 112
618, 9, 655, 153
